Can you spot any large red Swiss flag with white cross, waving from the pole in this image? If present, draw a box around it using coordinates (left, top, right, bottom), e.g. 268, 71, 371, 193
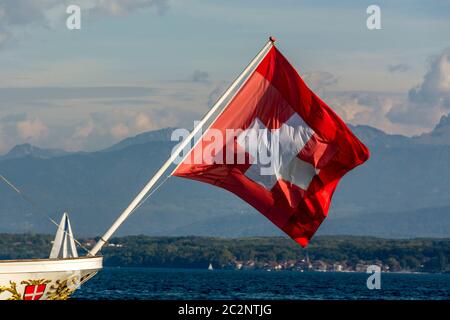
173, 46, 369, 247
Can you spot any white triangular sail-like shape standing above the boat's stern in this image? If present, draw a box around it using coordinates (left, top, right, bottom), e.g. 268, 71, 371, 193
50, 212, 78, 259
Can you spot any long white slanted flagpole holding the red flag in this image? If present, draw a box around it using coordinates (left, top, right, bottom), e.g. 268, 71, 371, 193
88, 37, 275, 256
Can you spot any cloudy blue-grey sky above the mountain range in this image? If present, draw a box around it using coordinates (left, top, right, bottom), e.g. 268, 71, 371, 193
0, 0, 450, 154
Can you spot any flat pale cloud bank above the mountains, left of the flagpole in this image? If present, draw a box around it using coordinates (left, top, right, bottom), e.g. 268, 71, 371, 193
0, 82, 209, 153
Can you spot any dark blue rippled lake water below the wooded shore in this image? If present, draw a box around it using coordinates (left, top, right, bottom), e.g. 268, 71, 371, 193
73, 268, 450, 300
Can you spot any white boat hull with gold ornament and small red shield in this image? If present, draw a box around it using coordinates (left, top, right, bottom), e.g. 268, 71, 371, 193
0, 257, 103, 300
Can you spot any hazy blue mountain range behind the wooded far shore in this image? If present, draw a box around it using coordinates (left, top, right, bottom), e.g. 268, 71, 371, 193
0, 116, 450, 237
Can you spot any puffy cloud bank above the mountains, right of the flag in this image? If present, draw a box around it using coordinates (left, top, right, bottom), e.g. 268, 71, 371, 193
320, 48, 450, 135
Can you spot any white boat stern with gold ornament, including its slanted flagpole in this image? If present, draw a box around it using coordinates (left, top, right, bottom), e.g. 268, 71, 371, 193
0, 37, 275, 300
